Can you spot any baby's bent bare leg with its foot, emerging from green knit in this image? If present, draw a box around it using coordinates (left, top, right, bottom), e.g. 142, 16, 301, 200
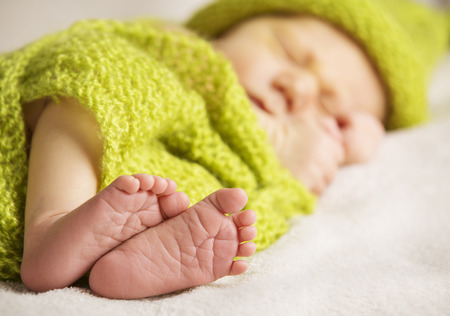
21, 100, 189, 291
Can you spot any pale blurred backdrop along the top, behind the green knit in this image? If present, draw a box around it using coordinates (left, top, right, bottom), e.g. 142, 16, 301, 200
0, 0, 450, 53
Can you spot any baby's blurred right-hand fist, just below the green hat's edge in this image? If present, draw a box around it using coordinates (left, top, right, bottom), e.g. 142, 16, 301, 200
340, 113, 385, 164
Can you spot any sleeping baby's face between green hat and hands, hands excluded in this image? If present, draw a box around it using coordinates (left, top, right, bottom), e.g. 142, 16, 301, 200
215, 16, 386, 120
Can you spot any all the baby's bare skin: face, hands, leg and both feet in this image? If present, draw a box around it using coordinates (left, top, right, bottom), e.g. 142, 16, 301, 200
18, 13, 385, 297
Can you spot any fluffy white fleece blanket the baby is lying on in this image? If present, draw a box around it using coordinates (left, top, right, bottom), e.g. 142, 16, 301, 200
0, 55, 450, 315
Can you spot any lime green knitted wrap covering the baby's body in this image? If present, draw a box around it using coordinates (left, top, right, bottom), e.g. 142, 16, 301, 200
0, 20, 315, 280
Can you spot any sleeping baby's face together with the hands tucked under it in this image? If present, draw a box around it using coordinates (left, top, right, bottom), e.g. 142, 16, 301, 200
213, 16, 386, 192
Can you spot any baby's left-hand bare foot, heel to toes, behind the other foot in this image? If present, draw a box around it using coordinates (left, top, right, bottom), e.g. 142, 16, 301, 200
22, 174, 189, 291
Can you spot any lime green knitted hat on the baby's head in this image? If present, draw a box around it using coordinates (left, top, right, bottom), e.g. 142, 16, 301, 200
186, 0, 450, 129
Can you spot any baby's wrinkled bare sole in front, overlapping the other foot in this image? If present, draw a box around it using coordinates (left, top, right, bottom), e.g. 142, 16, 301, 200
89, 189, 256, 298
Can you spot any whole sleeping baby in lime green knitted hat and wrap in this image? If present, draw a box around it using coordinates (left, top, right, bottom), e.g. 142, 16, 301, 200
0, 0, 449, 299
